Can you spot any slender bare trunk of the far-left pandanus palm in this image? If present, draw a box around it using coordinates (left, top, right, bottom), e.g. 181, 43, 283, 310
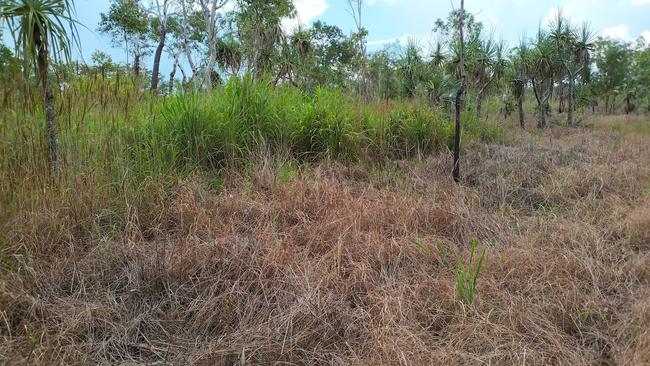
34, 31, 59, 173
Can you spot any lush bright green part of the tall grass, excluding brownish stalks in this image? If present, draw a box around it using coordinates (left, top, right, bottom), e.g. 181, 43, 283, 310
127, 78, 500, 169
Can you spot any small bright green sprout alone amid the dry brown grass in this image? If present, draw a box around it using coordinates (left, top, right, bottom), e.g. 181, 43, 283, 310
436, 240, 485, 305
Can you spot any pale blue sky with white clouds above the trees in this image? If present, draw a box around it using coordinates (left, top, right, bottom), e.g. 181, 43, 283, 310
5, 0, 650, 73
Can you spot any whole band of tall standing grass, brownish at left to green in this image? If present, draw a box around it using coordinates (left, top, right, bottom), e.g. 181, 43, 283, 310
0, 78, 503, 240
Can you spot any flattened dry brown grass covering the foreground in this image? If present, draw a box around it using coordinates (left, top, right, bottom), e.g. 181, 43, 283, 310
0, 119, 650, 365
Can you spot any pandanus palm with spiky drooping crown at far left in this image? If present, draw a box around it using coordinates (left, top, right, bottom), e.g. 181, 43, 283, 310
0, 0, 79, 172
